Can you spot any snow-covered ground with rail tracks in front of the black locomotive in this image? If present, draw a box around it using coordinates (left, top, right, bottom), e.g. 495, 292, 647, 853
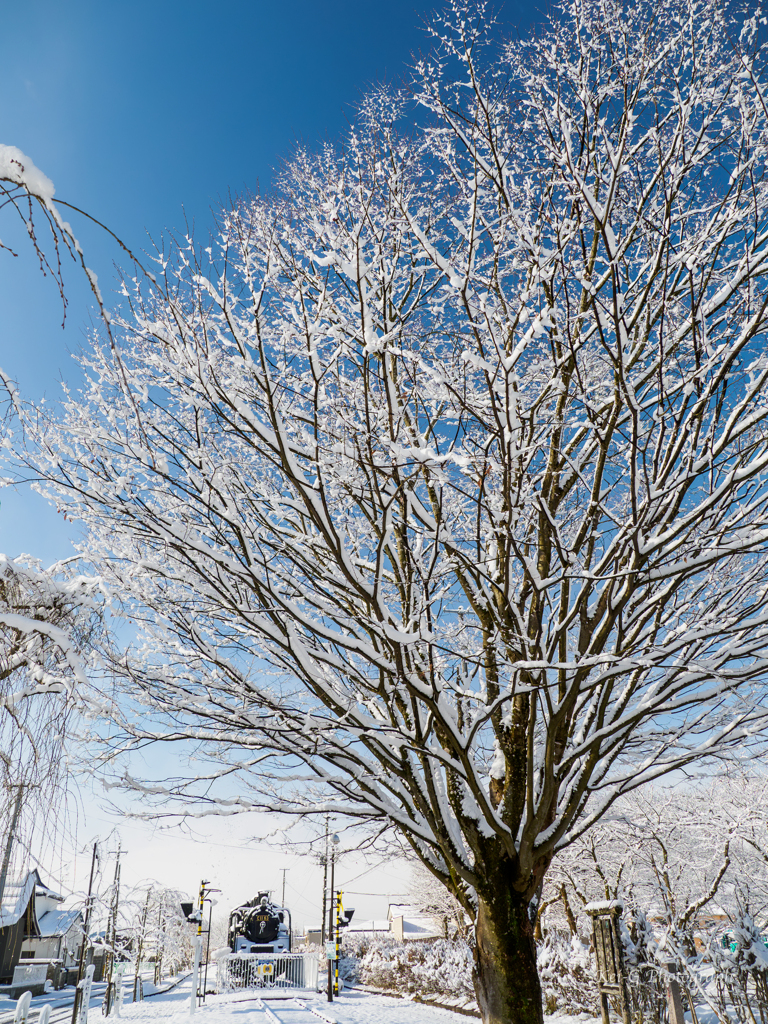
82, 981, 599, 1024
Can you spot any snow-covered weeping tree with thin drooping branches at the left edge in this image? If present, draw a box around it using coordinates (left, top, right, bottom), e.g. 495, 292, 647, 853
0, 144, 109, 847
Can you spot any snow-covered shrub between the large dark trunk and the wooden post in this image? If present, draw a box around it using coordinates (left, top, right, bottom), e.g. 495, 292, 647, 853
539, 931, 599, 1014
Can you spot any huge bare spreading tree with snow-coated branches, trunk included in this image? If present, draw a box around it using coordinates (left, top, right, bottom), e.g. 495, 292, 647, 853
22, 0, 768, 1024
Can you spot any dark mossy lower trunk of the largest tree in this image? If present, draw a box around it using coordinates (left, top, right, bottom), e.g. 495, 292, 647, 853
473, 886, 544, 1024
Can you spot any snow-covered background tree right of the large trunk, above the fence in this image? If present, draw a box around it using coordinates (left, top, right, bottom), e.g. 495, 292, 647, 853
542, 776, 768, 945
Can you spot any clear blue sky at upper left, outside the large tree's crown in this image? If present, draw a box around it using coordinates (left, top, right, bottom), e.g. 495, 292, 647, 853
0, 0, 543, 560
